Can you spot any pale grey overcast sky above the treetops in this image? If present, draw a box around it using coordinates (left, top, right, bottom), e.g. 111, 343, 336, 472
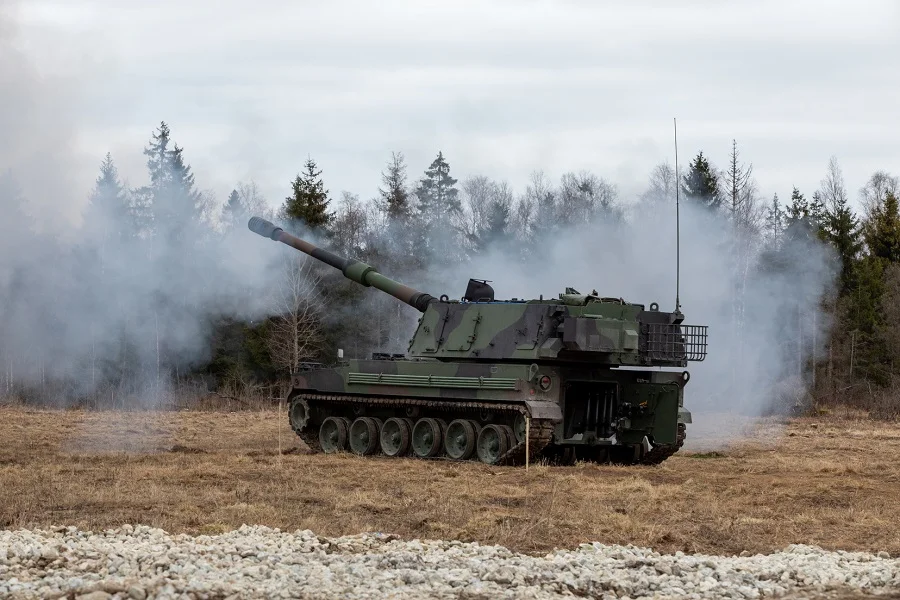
7, 0, 900, 225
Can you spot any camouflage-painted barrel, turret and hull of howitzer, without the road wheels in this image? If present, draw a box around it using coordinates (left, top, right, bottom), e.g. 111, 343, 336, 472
249, 217, 706, 462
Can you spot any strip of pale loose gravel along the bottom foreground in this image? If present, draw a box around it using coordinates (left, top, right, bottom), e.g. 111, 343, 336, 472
0, 525, 900, 600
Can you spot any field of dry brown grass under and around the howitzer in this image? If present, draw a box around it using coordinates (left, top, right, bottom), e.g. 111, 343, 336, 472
0, 408, 900, 556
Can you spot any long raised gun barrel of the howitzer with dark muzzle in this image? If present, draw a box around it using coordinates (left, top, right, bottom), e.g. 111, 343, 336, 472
247, 217, 435, 312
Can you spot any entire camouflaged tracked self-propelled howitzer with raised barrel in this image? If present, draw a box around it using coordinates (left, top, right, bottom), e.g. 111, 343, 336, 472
249, 217, 707, 464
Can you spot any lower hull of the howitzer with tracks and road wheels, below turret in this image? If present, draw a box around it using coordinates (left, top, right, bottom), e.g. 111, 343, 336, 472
288, 360, 690, 464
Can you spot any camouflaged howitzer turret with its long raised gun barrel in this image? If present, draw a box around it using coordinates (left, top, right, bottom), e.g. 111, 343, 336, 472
248, 217, 706, 367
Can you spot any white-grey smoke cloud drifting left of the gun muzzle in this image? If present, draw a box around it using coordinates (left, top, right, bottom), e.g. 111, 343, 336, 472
0, 0, 289, 404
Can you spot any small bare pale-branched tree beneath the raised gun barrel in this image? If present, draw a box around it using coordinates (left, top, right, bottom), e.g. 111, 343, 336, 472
267, 254, 324, 373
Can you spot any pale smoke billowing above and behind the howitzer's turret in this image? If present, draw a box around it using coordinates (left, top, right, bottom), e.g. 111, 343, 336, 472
424, 200, 837, 440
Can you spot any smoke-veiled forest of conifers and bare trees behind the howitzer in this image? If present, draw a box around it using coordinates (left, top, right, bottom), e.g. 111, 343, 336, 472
0, 122, 900, 418
